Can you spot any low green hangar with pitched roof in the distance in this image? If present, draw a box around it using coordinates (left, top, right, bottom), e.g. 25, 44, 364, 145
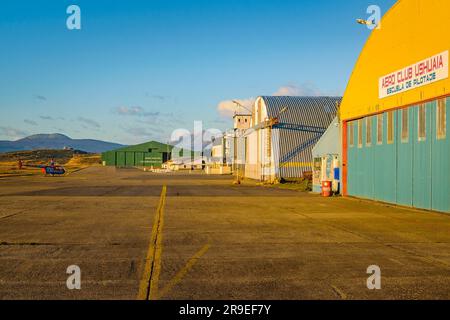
102, 141, 182, 168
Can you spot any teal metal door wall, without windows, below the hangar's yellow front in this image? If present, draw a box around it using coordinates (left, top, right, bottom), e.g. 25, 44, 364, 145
347, 98, 450, 212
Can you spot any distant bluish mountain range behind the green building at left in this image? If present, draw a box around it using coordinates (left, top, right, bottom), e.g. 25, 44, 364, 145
0, 133, 124, 153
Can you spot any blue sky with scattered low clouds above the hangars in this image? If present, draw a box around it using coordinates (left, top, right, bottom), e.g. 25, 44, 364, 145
0, 0, 395, 144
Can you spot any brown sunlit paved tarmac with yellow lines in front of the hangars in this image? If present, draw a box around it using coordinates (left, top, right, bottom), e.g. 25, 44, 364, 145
0, 167, 450, 299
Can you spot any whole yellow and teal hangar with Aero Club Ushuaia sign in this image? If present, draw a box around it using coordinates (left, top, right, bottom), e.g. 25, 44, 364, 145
340, 0, 450, 212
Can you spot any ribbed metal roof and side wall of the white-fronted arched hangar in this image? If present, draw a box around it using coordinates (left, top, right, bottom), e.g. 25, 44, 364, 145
261, 96, 342, 178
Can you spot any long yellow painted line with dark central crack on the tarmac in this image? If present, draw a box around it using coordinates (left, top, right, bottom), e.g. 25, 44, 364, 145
137, 186, 167, 300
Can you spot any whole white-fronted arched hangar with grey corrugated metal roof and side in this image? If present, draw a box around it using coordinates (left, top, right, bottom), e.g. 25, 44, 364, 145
242, 96, 341, 182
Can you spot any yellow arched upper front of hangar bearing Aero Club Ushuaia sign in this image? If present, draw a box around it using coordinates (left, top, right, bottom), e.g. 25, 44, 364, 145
340, 0, 450, 120
